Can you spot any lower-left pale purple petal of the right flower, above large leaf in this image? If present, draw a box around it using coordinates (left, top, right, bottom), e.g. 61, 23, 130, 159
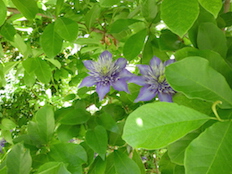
134, 86, 157, 103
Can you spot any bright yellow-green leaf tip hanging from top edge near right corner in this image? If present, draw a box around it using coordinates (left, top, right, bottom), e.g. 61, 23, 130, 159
198, 0, 222, 18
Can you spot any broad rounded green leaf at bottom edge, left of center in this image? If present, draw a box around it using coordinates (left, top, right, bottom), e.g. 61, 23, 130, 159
48, 143, 87, 174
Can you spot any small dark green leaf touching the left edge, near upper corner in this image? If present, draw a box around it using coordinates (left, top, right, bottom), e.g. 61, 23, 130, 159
0, 22, 16, 42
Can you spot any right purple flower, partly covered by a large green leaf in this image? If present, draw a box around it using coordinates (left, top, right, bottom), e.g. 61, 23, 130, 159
129, 57, 175, 102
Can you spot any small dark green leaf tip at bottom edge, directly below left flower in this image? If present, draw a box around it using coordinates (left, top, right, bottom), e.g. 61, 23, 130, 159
88, 156, 106, 174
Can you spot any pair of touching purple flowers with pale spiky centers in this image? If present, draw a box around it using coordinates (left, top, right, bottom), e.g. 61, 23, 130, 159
79, 51, 175, 102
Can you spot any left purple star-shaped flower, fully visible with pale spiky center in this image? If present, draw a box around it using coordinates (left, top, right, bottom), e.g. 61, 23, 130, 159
79, 51, 133, 100
